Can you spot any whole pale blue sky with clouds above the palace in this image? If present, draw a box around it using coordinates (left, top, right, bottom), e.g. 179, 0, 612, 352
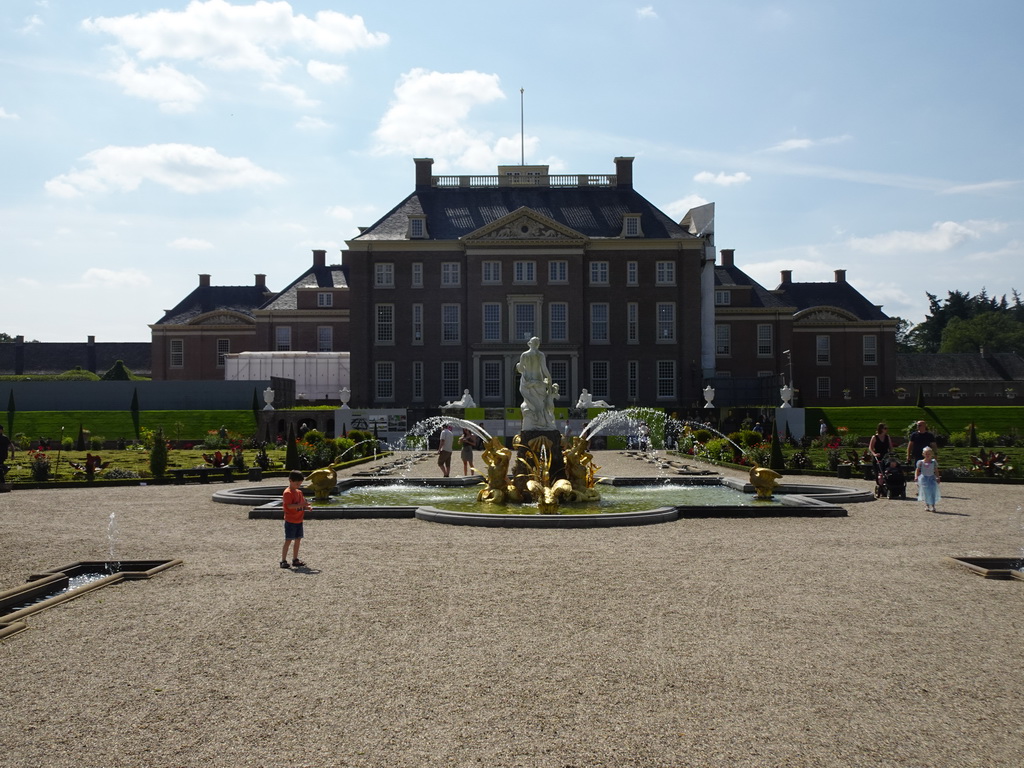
0, 0, 1024, 341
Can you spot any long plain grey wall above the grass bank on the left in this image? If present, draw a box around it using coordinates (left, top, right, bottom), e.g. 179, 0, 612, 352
0, 381, 270, 411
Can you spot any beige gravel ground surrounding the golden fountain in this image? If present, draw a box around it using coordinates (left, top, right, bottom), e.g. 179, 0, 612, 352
0, 452, 1024, 768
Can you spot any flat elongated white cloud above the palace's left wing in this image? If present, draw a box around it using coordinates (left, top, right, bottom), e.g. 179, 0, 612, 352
45, 144, 284, 198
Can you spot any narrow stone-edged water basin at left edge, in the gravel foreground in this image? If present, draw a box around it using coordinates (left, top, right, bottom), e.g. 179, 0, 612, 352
0, 560, 182, 639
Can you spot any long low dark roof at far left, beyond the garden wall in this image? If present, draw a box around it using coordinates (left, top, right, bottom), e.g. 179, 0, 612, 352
0, 341, 153, 376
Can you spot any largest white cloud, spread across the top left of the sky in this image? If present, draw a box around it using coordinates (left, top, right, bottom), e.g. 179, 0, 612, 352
82, 0, 388, 107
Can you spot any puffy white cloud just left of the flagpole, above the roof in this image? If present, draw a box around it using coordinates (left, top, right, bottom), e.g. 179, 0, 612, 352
374, 69, 538, 168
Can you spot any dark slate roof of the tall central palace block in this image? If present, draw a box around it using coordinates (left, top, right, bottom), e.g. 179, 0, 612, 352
355, 186, 694, 241
